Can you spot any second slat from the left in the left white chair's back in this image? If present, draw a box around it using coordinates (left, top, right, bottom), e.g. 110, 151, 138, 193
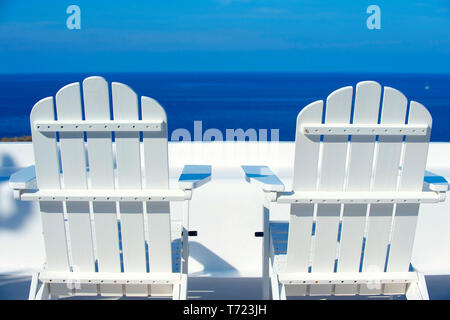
56, 82, 97, 295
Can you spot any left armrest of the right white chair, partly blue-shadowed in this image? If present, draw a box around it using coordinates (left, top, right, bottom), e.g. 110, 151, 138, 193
241, 166, 284, 192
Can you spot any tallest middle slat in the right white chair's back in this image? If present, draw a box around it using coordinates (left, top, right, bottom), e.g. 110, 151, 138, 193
334, 81, 381, 295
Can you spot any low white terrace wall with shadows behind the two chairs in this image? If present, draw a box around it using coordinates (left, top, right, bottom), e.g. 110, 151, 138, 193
0, 142, 450, 276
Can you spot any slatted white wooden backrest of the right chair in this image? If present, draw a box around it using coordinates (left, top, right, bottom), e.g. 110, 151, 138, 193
287, 81, 431, 294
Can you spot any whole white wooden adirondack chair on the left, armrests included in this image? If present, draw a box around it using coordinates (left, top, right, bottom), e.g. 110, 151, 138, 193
10, 77, 211, 299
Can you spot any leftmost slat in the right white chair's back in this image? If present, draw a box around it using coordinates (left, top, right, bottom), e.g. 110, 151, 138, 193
286, 100, 323, 297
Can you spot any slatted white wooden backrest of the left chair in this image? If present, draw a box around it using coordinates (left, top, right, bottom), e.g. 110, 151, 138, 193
30, 77, 172, 295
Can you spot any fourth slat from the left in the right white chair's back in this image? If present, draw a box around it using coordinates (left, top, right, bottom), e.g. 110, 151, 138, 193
360, 87, 407, 294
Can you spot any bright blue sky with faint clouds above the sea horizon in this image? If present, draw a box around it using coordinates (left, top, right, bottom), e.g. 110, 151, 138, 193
0, 0, 450, 73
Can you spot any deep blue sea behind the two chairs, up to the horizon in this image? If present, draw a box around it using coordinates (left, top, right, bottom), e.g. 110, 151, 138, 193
0, 73, 450, 141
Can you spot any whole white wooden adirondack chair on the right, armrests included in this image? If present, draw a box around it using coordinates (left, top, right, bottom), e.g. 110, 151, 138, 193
243, 81, 448, 299
